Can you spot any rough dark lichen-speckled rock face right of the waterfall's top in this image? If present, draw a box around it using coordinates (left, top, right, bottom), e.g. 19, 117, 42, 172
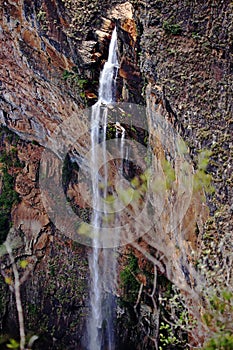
136, 1, 232, 290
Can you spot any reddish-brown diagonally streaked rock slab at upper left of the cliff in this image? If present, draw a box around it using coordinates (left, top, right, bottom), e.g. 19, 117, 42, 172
1, 2, 77, 144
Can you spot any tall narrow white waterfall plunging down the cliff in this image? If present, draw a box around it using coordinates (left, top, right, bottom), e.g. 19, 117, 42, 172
88, 28, 120, 350
